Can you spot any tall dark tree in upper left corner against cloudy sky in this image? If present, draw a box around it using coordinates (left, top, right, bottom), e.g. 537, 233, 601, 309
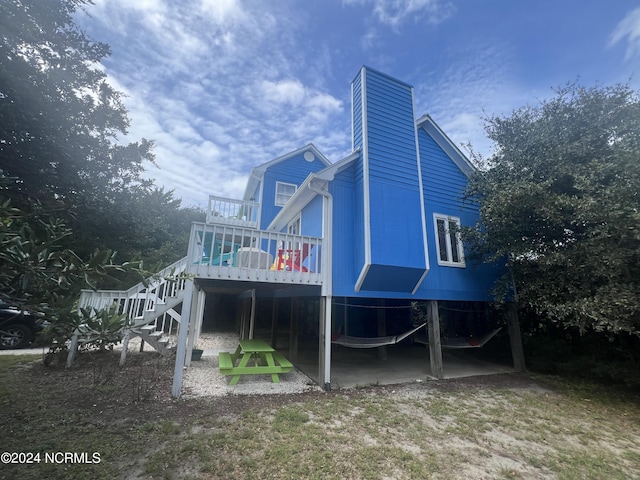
0, 0, 153, 220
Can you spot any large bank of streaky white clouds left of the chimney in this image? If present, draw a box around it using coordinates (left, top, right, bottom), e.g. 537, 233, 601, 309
79, 0, 350, 206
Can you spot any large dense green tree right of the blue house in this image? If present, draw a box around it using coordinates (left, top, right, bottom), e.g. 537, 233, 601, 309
468, 84, 640, 335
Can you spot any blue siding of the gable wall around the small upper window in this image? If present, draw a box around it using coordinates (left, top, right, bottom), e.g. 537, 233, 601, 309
258, 152, 325, 228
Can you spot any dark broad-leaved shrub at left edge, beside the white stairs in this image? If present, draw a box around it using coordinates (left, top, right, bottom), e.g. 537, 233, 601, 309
0, 195, 143, 346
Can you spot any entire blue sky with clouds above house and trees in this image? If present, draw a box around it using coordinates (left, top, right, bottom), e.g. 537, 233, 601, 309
77, 0, 640, 207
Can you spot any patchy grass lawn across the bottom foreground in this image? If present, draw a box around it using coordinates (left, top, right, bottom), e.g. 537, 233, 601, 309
0, 353, 640, 480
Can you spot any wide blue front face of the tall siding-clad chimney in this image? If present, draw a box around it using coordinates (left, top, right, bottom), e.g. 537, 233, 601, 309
354, 69, 426, 292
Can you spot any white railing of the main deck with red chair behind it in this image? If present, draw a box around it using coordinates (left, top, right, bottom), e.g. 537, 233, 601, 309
187, 223, 322, 285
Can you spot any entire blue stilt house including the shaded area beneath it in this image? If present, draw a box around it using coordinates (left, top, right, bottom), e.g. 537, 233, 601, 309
68, 66, 524, 397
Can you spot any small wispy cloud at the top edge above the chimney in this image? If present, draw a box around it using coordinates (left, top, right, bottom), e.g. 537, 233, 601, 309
344, 0, 455, 28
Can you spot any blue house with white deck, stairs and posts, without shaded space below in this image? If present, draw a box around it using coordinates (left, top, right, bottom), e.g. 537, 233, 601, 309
75, 67, 523, 396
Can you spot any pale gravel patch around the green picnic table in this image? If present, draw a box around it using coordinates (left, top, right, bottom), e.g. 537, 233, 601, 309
182, 333, 322, 398
